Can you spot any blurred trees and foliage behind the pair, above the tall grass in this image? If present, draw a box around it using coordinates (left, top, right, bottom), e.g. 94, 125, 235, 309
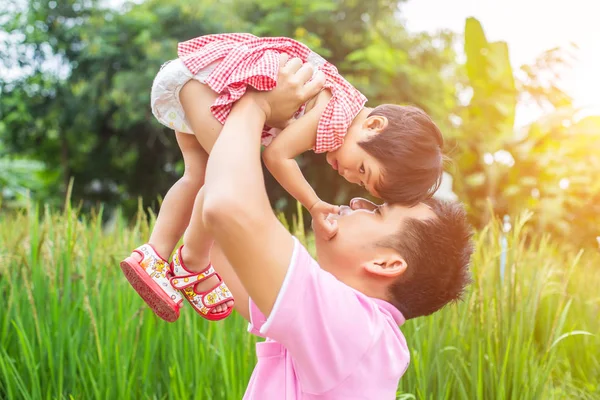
0, 0, 600, 246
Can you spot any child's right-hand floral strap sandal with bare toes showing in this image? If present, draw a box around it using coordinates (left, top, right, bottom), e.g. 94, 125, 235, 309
170, 246, 233, 321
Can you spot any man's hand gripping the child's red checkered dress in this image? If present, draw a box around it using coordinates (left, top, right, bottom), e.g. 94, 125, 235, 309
244, 54, 325, 129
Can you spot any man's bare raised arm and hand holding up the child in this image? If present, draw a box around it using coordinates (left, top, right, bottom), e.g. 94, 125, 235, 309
203, 57, 324, 316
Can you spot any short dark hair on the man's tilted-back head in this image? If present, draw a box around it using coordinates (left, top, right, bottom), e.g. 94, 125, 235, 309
380, 199, 473, 319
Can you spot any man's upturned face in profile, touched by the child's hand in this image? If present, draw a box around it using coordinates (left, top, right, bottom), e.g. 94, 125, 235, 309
316, 198, 435, 286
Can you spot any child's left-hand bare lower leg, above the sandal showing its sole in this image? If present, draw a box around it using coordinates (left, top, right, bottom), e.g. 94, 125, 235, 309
149, 132, 208, 259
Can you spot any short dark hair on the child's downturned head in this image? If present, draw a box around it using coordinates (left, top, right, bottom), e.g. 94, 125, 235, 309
359, 104, 444, 206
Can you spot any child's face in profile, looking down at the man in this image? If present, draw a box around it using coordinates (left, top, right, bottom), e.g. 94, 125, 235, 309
327, 129, 383, 197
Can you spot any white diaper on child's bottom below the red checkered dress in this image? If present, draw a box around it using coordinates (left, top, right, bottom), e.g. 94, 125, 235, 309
150, 58, 219, 135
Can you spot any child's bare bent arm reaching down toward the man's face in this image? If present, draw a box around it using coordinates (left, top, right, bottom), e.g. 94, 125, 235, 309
263, 91, 331, 211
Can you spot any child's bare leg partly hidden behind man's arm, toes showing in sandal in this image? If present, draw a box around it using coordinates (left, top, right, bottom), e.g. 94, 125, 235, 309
179, 80, 233, 313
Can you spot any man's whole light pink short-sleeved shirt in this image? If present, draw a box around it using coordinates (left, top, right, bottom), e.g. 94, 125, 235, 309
244, 238, 409, 400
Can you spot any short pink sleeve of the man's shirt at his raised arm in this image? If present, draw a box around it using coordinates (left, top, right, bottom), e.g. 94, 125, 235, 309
249, 239, 387, 394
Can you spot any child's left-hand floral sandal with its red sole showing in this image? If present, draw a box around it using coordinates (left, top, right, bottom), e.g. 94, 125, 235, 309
121, 244, 183, 322
